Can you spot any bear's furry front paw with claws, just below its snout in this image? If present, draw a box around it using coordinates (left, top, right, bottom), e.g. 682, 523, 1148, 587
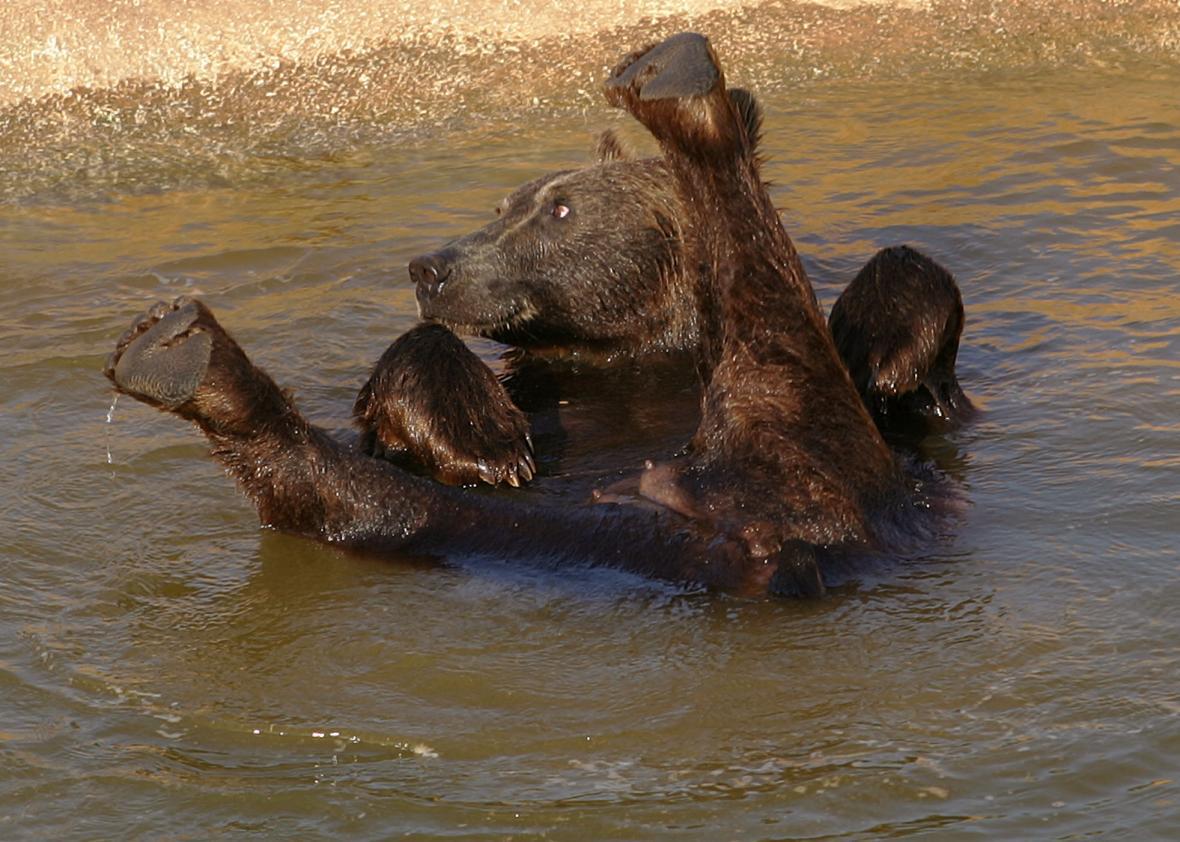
353, 324, 537, 487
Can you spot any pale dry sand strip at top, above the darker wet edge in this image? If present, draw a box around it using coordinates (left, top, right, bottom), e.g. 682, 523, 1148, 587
0, 0, 1180, 107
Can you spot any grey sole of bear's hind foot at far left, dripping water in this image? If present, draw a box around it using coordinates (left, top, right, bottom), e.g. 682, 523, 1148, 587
103, 297, 224, 409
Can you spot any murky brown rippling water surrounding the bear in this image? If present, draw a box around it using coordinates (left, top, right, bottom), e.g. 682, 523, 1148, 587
0, 2, 1180, 840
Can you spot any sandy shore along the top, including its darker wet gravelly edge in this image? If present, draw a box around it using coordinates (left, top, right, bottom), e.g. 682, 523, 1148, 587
0, 0, 1180, 200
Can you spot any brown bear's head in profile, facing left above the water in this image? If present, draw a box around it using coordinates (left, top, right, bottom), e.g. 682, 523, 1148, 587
409, 134, 696, 356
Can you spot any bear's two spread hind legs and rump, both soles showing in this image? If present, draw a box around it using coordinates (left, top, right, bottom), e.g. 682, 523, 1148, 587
105, 33, 943, 594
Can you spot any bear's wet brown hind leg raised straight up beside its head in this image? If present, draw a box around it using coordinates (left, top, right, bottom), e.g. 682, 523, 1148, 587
608, 31, 900, 577
